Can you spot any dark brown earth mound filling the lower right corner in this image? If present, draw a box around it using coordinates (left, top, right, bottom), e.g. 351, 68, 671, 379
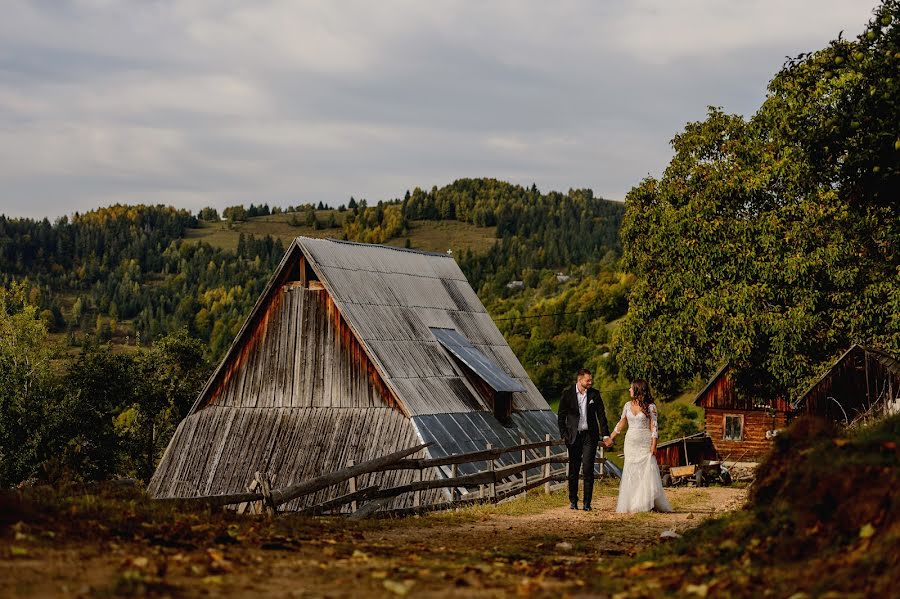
639, 416, 900, 597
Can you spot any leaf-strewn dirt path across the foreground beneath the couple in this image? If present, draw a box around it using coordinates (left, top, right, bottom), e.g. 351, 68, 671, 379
0, 487, 745, 597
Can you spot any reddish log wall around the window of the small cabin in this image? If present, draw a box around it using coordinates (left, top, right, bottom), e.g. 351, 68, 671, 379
706, 408, 787, 462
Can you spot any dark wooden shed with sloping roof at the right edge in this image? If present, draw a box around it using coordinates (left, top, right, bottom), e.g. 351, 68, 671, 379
794, 344, 900, 425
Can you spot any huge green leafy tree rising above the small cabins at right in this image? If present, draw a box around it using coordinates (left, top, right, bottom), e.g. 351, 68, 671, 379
616, 0, 900, 404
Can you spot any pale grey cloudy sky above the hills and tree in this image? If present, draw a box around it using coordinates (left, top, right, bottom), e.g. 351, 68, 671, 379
0, 0, 877, 220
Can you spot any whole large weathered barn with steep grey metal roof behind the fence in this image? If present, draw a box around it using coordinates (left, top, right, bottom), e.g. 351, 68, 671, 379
148, 237, 564, 510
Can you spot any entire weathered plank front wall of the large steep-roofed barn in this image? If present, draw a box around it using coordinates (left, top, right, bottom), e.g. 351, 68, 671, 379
149, 284, 440, 509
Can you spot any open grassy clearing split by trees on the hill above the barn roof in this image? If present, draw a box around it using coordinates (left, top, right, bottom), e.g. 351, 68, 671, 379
179, 210, 496, 252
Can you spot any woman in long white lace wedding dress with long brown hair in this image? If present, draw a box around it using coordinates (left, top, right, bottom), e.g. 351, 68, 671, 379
610, 379, 672, 512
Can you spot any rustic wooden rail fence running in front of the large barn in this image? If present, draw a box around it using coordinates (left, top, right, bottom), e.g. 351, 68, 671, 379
165, 435, 606, 518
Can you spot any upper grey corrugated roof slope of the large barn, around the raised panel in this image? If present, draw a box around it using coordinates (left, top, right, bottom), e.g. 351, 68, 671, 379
294, 237, 550, 416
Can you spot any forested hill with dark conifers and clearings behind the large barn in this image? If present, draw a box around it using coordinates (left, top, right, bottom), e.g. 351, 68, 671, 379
0, 179, 624, 361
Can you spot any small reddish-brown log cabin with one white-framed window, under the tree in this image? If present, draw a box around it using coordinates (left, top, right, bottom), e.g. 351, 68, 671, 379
694, 365, 791, 462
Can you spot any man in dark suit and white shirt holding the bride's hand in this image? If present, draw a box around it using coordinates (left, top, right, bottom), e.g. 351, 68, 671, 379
557, 368, 612, 512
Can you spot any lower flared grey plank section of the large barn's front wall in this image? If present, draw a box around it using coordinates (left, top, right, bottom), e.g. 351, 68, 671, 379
148, 406, 440, 510
